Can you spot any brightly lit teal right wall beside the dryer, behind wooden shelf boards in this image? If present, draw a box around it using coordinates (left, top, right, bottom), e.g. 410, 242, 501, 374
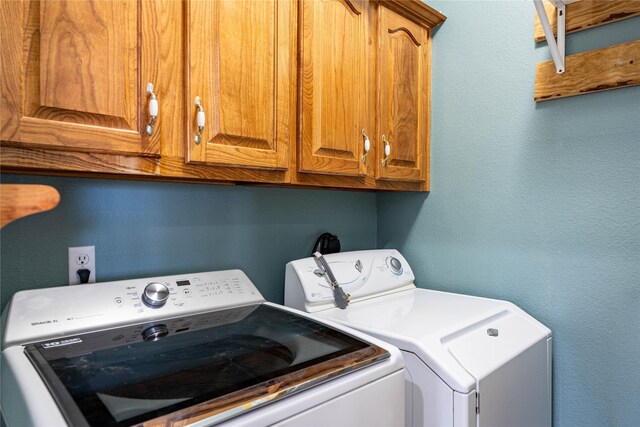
378, 1, 640, 427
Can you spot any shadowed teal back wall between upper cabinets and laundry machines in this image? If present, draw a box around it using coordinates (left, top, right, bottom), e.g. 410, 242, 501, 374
0, 175, 376, 307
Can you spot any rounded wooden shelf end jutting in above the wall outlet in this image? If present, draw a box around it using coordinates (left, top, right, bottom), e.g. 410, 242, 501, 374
0, 184, 60, 227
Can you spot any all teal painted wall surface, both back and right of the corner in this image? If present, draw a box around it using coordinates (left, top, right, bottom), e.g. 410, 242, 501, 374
0, 1, 640, 427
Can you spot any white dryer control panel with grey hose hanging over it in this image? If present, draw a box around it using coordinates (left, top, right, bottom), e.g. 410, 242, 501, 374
284, 249, 415, 312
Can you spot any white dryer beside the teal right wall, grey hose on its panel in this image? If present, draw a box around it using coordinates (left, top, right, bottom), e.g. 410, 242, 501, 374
285, 250, 551, 427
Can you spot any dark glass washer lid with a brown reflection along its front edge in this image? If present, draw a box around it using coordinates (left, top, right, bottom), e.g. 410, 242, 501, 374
25, 304, 389, 426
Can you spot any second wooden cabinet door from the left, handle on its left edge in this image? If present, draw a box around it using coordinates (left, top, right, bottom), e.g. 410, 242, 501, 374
186, 0, 296, 169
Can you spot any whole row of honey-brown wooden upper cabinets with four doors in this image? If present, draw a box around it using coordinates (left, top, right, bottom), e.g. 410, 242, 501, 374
0, 0, 446, 191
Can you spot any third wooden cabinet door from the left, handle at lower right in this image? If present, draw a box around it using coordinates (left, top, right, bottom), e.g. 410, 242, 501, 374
298, 0, 375, 176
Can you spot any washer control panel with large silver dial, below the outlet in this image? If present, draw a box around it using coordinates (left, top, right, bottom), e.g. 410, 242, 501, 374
2, 270, 265, 349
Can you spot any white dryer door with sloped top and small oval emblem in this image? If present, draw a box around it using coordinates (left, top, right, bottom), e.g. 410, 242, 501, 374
443, 311, 551, 427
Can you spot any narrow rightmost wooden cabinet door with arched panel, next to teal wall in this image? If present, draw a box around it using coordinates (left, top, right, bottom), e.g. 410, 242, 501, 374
376, 7, 431, 181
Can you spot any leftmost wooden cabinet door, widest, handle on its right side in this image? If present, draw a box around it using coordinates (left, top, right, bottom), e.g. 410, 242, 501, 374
1, 0, 160, 155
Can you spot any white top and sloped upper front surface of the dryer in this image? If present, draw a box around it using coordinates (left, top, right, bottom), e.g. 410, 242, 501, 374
319, 289, 550, 393
